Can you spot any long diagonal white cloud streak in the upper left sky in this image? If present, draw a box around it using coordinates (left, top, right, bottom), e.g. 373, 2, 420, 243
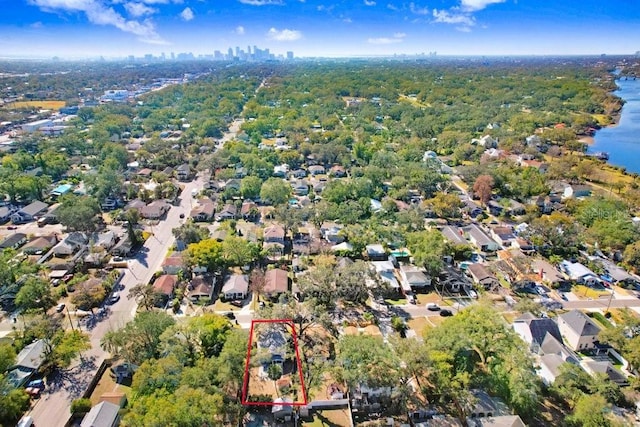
28, 0, 167, 44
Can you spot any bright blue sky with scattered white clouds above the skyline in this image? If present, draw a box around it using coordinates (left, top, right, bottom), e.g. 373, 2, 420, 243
0, 0, 640, 57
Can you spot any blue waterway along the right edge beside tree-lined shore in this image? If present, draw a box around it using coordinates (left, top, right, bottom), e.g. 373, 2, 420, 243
589, 79, 640, 173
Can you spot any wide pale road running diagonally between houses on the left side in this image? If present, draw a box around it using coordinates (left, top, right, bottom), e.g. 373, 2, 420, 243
29, 178, 203, 427
